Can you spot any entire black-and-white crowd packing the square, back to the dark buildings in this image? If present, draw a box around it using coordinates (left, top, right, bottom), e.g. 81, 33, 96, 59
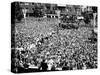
11, 3, 98, 72
